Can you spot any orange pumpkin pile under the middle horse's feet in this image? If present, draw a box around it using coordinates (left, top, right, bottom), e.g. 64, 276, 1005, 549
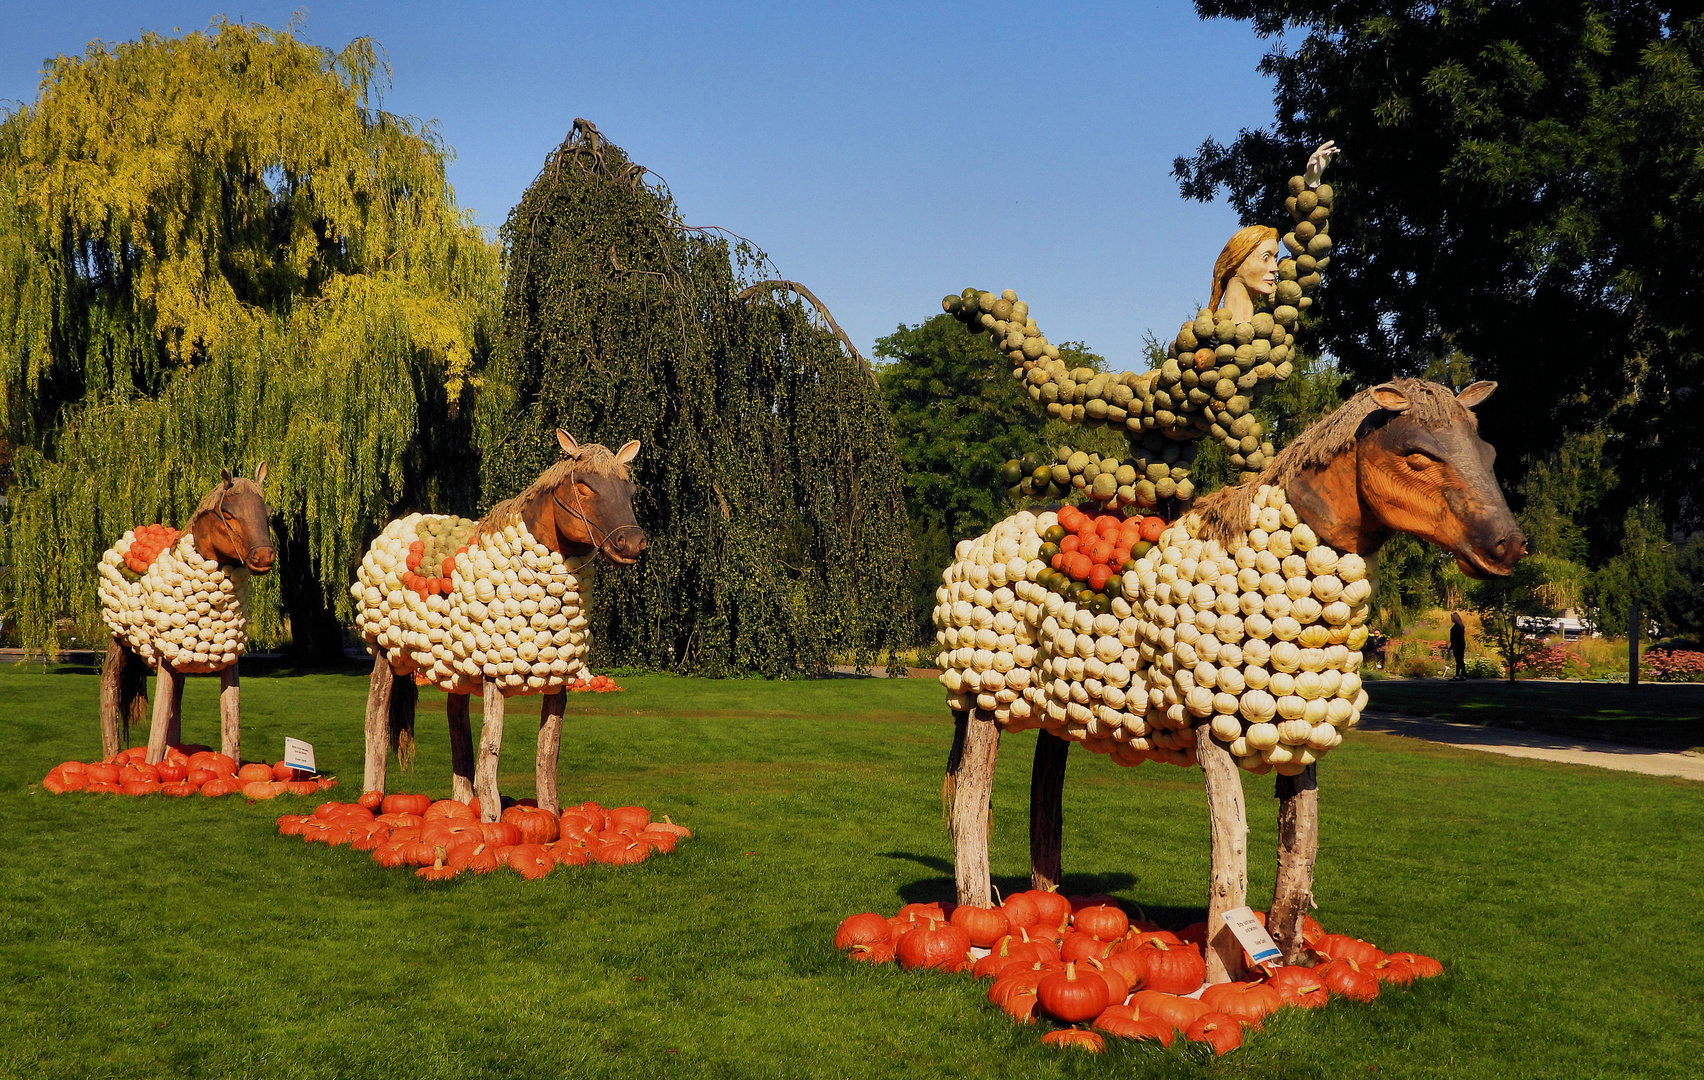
278, 790, 692, 881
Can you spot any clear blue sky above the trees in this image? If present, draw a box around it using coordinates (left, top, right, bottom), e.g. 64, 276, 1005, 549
0, 0, 1281, 368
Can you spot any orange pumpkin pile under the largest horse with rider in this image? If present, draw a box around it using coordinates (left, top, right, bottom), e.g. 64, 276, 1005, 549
835, 889, 1443, 1054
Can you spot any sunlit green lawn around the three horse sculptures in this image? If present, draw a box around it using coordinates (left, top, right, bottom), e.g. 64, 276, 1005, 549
0, 669, 1704, 1080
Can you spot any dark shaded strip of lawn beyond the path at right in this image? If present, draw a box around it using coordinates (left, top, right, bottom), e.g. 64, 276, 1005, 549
1367, 678, 1704, 750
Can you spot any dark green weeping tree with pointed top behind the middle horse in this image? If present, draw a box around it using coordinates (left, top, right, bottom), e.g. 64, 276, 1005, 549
477, 121, 908, 675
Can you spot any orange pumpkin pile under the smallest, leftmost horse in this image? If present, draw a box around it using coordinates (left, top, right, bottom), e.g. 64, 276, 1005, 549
41, 746, 337, 799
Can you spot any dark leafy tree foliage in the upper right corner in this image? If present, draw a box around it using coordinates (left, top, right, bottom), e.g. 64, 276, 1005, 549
1177, 0, 1704, 520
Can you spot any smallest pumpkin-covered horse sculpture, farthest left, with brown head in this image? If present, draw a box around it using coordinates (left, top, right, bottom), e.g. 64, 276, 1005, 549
101, 462, 276, 765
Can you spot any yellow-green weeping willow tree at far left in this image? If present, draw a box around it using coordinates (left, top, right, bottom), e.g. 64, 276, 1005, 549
0, 20, 501, 652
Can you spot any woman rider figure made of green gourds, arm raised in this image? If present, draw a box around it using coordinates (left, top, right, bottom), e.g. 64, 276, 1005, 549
942, 141, 1338, 518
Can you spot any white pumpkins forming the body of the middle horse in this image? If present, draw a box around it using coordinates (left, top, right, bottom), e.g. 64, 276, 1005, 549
349, 514, 590, 695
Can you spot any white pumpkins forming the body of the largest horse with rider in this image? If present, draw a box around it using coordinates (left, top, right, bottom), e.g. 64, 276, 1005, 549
935, 485, 1372, 773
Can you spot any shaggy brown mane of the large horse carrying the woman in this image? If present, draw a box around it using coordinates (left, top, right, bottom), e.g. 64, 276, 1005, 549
1193, 378, 1479, 550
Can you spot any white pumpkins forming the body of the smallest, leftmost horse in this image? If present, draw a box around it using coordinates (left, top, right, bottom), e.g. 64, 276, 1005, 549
99, 531, 249, 675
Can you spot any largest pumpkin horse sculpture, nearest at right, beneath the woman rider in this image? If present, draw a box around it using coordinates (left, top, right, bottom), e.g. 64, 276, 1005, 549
935, 380, 1525, 981
